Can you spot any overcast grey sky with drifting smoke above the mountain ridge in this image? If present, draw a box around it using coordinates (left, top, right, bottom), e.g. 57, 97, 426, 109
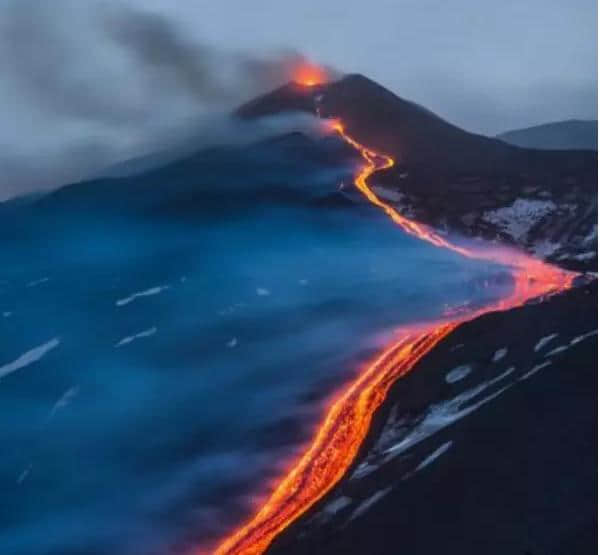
0, 0, 597, 200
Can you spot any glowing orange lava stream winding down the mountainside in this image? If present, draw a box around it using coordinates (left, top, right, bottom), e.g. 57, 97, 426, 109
215, 122, 575, 555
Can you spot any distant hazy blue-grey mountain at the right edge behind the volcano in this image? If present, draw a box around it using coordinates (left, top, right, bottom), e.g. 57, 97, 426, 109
497, 119, 598, 150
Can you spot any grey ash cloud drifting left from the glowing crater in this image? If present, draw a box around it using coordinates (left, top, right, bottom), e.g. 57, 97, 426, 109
0, 0, 318, 201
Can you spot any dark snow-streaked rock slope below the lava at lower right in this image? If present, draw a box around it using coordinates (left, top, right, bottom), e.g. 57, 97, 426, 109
269, 283, 597, 555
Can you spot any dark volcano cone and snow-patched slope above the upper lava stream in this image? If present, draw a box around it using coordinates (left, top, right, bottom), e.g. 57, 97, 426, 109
236, 75, 597, 269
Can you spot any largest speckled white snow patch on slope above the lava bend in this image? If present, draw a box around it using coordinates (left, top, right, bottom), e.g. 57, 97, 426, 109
482, 198, 557, 241
